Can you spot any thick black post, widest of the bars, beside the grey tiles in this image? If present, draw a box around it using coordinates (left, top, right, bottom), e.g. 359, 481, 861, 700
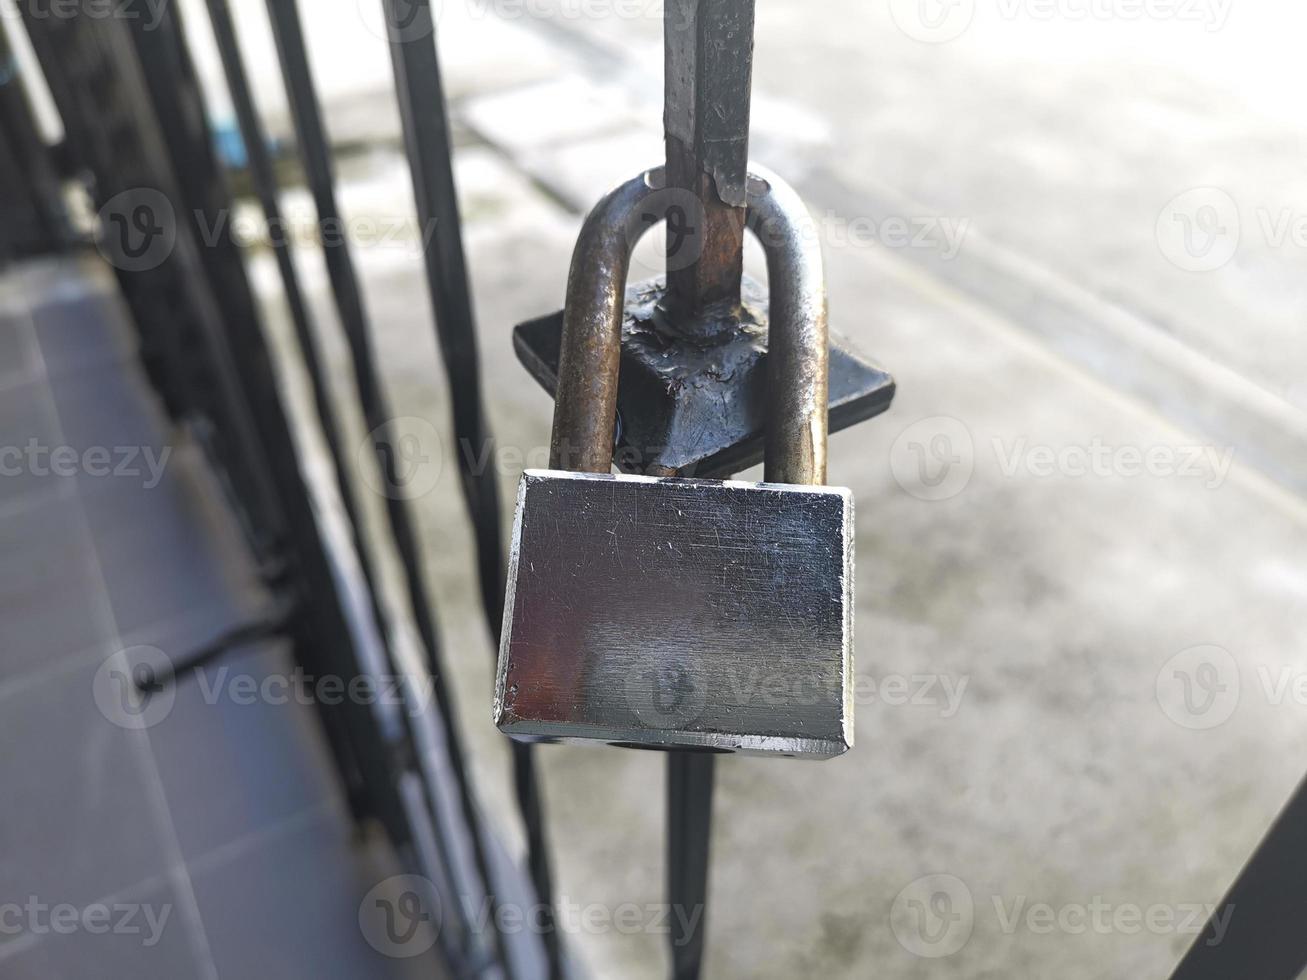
22, 4, 423, 857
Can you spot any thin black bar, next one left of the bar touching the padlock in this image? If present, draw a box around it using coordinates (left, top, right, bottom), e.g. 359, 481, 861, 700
268, 0, 505, 962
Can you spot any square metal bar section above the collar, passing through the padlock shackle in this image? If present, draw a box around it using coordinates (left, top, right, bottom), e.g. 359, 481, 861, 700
664, 0, 754, 333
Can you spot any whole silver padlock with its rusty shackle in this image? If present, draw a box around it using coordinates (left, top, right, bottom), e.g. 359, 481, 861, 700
494, 167, 853, 758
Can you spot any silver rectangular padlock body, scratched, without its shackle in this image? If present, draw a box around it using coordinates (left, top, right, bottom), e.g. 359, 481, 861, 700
494, 470, 853, 758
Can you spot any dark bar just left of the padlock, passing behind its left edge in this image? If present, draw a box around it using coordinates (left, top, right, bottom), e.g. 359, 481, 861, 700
383, 0, 562, 977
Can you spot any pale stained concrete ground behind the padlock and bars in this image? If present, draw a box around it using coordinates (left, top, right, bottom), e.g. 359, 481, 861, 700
163, 0, 1307, 977
